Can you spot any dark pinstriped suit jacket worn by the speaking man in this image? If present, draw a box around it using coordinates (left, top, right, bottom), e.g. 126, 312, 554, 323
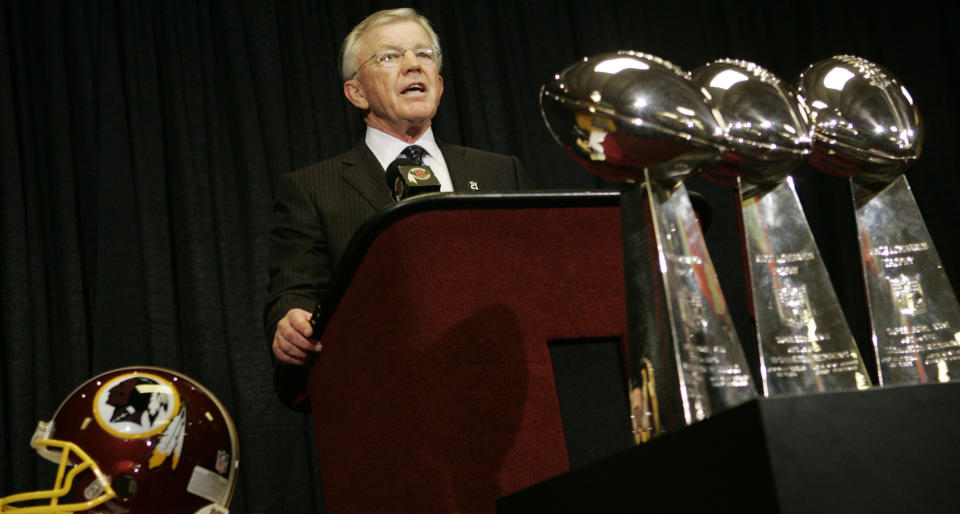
264, 142, 523, 341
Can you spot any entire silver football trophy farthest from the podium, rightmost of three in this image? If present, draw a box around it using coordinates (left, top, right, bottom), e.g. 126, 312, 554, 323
798, 56, 960, 385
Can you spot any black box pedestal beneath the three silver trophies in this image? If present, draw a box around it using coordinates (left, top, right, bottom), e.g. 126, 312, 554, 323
497, 383, 960, 513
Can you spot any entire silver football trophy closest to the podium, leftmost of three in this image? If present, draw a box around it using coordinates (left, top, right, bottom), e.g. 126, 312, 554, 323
540, 52, 756, 442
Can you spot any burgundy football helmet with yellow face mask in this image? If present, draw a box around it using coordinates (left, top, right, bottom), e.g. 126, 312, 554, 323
0, 367, 240, 514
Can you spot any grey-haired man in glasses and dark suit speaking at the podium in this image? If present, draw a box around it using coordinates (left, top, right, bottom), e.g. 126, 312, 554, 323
264, 9, 522, 365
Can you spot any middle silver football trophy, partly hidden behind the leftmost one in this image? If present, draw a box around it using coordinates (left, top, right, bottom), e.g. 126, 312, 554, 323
691, 60, 870, 396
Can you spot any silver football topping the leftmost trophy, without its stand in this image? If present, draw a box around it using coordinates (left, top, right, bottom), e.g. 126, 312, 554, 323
540, 51, 724, 181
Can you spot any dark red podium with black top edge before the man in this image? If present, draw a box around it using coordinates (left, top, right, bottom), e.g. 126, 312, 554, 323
290, 192, 629, 513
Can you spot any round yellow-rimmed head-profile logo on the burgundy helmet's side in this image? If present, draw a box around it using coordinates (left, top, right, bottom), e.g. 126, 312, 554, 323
93, 372, 181, 439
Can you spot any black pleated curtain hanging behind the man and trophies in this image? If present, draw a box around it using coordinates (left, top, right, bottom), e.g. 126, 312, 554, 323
0, 0, 960, 513
